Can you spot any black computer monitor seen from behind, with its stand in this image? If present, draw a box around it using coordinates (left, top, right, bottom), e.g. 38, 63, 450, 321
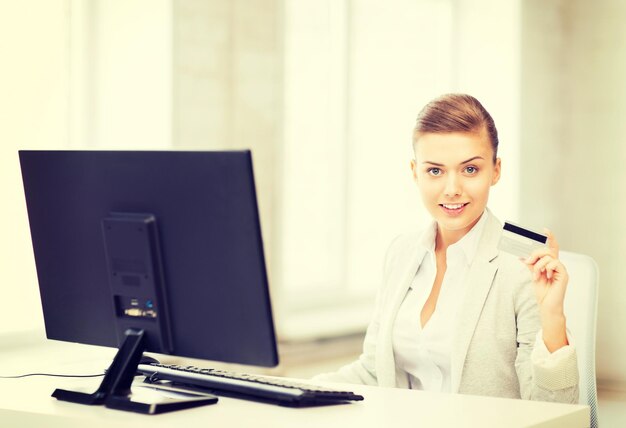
19, 150, 278, 411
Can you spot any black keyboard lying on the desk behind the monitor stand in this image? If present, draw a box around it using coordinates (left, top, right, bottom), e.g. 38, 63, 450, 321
138, 364, 363, 407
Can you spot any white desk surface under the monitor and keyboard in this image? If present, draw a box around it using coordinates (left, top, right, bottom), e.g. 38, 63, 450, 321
0, 334, 589, 428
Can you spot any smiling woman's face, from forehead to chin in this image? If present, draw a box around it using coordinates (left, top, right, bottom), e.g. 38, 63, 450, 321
411, 130, 500, 243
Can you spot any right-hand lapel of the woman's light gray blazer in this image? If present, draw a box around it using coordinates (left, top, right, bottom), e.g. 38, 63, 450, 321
450, 212, 502, 392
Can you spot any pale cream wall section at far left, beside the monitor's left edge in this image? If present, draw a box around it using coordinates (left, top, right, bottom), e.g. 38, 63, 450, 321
0, 0, 69, 332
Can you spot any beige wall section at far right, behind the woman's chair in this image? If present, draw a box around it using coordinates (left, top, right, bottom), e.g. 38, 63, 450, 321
520, 0, 626, 389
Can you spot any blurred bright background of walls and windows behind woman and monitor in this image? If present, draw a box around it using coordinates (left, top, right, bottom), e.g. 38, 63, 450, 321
0, 0, 626, 420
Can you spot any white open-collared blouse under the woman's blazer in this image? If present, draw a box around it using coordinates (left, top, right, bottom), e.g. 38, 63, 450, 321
392, 213, 487, 392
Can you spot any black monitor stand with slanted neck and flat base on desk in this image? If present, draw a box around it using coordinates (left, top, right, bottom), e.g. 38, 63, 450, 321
52, 329, 217, 415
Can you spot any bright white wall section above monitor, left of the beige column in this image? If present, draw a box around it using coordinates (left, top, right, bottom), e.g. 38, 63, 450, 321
68, 0, 172, 149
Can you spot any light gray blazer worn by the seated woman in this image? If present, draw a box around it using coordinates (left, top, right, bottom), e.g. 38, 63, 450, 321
316, 211, 578, 403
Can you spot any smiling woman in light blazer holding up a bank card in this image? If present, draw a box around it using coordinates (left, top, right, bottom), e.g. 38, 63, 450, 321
318, 94, 578, 402
